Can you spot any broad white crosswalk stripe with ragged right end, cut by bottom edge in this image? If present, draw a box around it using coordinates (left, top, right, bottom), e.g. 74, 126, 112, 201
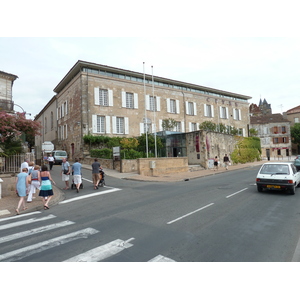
65, 238, 134, 262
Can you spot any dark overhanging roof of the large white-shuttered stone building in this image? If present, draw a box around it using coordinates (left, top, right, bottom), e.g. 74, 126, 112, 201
53, 60, 252, 101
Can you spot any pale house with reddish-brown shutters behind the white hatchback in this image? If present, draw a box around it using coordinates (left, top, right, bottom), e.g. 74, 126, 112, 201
250, 114, 292, 158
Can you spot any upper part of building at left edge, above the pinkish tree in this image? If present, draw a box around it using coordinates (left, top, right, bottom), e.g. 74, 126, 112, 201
0, 71, 18, 113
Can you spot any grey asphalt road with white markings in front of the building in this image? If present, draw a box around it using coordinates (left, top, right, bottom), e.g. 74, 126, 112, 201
0, 167, 300, 262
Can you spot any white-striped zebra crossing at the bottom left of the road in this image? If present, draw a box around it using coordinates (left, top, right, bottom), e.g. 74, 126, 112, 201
0, 212, 174, 262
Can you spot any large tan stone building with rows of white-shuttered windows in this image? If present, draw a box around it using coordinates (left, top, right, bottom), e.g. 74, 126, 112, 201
35, 61, 251, 159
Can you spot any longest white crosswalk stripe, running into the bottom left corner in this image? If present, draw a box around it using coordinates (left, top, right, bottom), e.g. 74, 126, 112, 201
0, 228, 99, 261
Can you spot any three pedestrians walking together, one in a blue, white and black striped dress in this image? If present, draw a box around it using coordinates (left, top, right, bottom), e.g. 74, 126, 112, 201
16, 159, 55, 214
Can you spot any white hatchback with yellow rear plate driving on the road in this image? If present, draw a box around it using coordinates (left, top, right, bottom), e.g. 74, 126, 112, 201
256, 162, 300, 195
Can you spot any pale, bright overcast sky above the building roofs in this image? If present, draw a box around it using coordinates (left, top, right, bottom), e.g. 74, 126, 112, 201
0, 37, 300, 118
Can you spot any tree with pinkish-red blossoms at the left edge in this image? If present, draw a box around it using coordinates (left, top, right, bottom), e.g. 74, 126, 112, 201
0, 111, 42, 155
